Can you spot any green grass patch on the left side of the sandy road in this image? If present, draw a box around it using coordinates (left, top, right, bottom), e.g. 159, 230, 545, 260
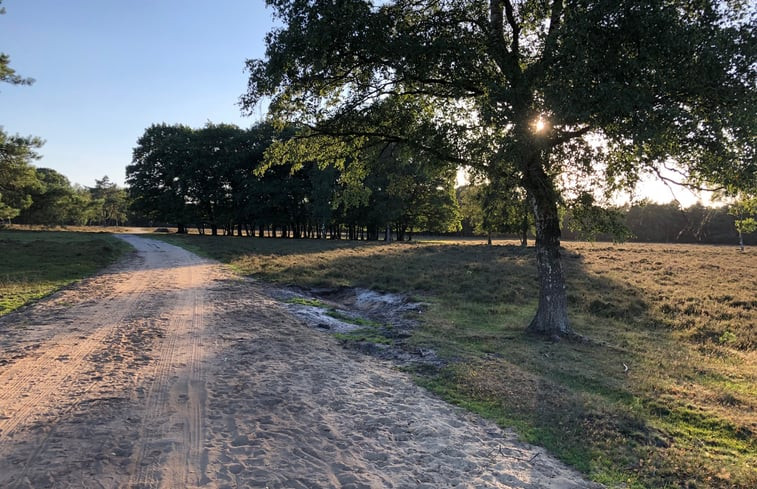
0, 230, 129, 315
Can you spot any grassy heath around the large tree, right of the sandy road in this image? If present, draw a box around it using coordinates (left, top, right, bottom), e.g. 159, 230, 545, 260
155, 236, 757, 488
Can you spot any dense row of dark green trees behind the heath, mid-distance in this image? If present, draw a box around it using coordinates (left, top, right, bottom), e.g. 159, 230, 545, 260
126, 124, 459, 239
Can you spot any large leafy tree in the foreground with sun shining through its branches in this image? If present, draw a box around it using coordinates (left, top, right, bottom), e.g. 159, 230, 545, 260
242, 0, 757, 336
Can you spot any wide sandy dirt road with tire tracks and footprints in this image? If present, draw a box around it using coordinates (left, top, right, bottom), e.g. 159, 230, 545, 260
0, 235, 595, 489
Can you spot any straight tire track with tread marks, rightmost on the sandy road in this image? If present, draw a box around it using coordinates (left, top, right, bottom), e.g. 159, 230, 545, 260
128, 240, 209, 488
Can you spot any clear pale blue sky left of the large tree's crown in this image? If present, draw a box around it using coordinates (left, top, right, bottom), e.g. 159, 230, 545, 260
0, 0, 273, 186
